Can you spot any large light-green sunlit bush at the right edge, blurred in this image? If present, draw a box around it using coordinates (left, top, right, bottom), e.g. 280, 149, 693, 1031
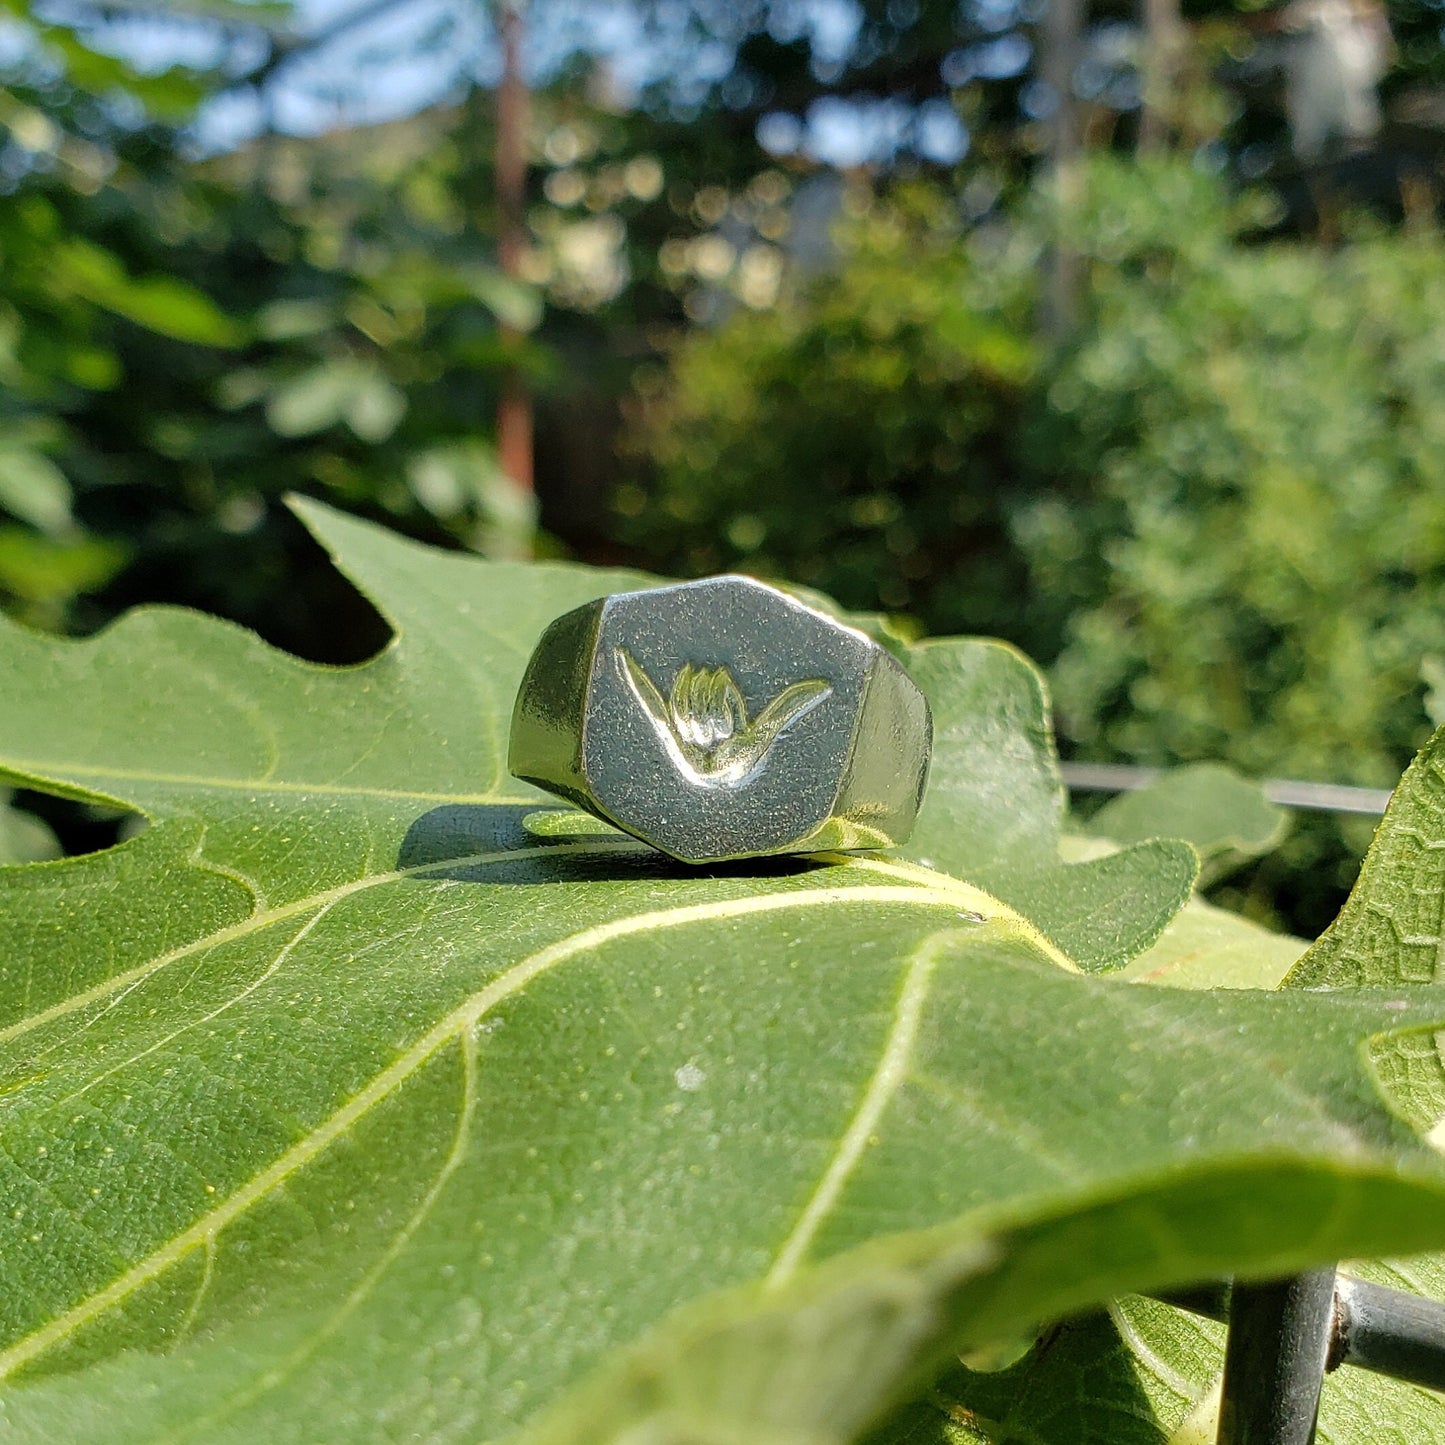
1016, 159, 1445, 803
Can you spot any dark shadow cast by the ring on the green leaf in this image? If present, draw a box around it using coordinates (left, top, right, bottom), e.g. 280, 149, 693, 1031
396, 802, 835, 884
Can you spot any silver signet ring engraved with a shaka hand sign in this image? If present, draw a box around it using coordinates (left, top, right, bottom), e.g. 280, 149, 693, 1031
509, 577, 932, 863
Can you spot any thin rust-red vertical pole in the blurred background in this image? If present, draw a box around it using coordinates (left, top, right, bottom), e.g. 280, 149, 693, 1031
496, 0, 532, 491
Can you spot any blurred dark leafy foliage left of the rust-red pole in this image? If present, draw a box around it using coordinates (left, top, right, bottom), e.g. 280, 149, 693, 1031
0, 6, 545, 655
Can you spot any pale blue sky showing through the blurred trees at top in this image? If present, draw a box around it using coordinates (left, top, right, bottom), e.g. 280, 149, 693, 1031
36, 0, 971, 168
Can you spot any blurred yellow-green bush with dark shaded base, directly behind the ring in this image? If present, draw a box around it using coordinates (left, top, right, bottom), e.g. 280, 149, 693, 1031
617, 186, 1038, 636
